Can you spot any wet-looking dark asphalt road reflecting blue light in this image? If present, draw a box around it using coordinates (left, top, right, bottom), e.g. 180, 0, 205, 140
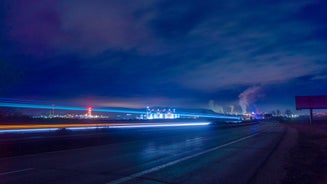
0, 123, 285, 184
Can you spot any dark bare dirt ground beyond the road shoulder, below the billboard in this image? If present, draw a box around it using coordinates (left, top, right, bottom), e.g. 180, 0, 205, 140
282, 121, 327, 184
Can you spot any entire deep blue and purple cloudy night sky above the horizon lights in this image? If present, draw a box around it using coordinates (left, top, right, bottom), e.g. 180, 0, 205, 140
0, 0, 327, 112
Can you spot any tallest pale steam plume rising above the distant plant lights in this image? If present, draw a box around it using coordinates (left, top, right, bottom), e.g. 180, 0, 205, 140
238, 86, 261, 114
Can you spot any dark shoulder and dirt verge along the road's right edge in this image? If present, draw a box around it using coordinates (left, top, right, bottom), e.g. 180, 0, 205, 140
251, 123, 327, 184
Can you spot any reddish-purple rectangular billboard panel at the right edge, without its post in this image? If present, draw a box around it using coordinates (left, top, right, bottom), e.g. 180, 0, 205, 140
295, 96, 327, 110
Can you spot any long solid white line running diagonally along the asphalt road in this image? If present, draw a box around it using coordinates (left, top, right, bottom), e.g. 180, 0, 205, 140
107, 133, 259, 184
